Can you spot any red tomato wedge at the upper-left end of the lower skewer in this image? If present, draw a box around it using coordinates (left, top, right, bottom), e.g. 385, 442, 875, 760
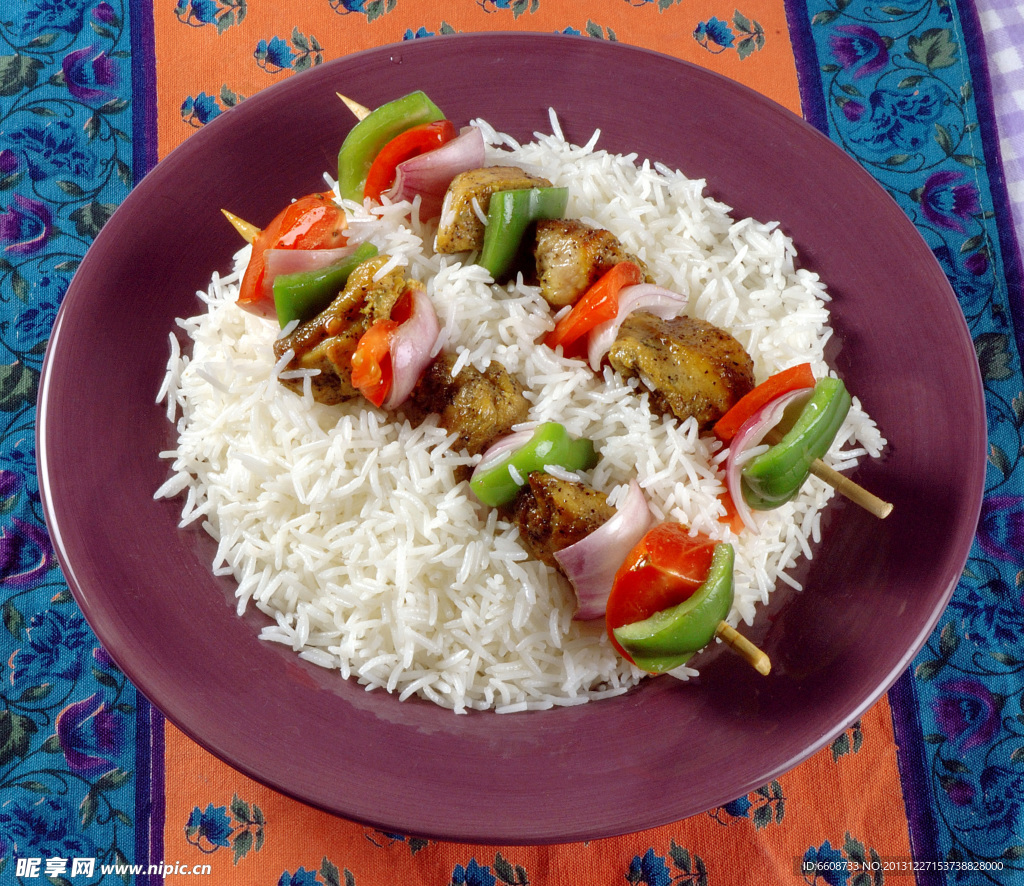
239, 191, 346, 310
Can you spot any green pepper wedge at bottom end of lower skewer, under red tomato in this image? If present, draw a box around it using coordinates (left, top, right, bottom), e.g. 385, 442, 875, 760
612, 542, 735, 674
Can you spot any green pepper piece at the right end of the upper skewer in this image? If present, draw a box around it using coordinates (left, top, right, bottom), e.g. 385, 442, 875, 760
740, 378, 851, 511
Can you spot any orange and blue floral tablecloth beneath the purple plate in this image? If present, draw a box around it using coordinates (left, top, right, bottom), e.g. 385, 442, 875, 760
0, 0, 1024, 886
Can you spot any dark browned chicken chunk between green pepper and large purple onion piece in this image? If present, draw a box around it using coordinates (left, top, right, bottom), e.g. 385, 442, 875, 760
508, 471, 615, 568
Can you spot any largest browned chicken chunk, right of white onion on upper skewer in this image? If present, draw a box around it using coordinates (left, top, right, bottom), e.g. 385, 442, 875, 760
608, 311, 754, 430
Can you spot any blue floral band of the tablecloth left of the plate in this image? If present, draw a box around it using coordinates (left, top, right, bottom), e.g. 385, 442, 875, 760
0, 0, 150, 884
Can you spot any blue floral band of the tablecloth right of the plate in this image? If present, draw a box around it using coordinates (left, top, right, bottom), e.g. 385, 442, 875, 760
805, 0, 1024, 883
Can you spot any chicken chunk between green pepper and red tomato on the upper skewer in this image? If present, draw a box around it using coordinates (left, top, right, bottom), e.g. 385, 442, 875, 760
534, 218, 647, 307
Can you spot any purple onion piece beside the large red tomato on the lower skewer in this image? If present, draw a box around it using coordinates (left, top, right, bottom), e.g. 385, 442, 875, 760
555, 480, 654, 621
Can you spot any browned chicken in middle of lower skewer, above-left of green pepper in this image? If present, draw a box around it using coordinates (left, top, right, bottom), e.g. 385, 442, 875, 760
402, 352, 529, 455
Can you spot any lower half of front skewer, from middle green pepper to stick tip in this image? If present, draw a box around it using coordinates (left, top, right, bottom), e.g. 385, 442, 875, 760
470, 432, 771, 674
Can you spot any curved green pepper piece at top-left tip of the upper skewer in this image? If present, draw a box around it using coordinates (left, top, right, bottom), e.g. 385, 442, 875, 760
338, 90, 444, 202
